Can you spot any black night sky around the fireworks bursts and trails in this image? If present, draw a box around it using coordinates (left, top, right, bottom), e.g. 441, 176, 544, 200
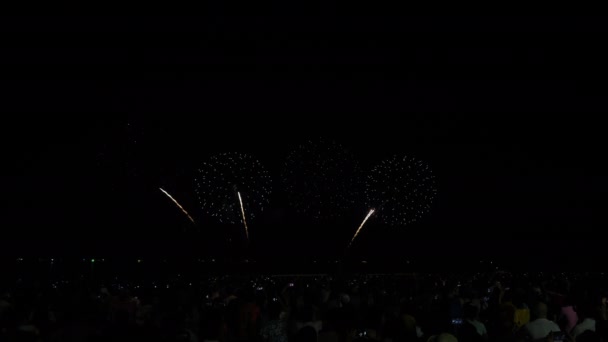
0, 12, 608, 256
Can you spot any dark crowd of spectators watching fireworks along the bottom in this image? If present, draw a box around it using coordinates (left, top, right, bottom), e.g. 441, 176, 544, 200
0, 272, 608, 342
